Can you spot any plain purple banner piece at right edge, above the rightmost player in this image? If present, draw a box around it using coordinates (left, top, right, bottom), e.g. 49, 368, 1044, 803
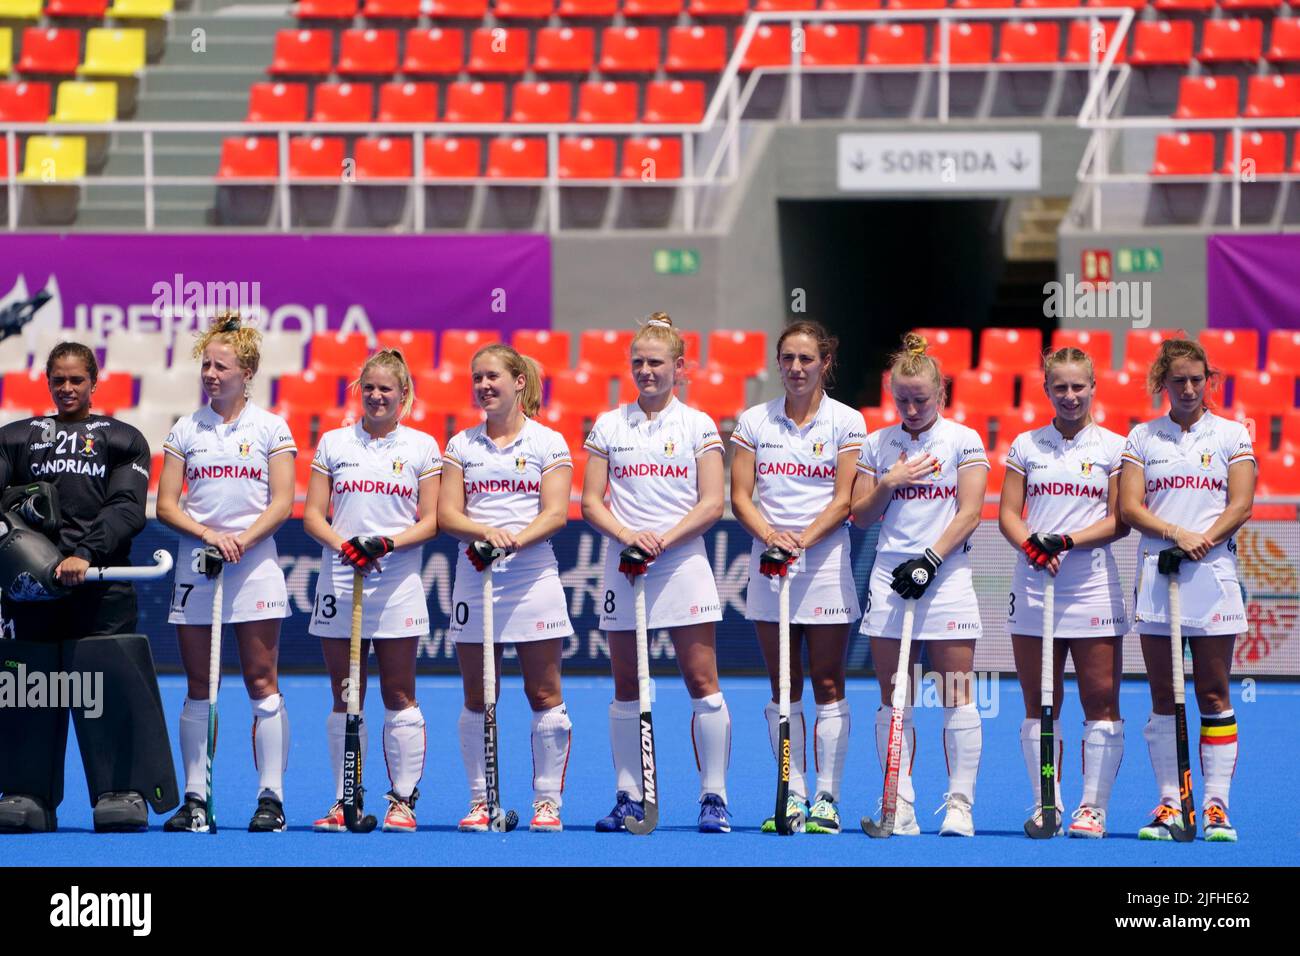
1205, 235, 1300, 347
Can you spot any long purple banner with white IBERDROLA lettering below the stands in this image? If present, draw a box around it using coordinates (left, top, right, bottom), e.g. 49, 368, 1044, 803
0, 234, 551, 341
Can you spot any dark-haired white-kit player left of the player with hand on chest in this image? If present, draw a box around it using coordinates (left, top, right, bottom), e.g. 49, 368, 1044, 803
732, 321, 866, 834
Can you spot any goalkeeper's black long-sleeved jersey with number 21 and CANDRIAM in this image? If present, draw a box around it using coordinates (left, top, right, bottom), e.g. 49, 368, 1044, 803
0, 415, 150, 567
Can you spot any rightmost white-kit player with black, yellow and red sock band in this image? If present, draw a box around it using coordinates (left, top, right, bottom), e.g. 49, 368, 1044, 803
1119, 339, 1256, 843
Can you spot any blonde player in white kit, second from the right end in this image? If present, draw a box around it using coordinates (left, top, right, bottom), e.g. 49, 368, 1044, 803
998, 349, 1128, 838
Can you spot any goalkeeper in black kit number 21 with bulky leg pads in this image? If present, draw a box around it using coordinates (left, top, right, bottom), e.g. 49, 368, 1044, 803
0, 342, 178, 832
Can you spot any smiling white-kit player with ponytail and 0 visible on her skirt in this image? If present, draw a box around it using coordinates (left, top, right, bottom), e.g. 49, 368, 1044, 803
438, 342, 573, 832
